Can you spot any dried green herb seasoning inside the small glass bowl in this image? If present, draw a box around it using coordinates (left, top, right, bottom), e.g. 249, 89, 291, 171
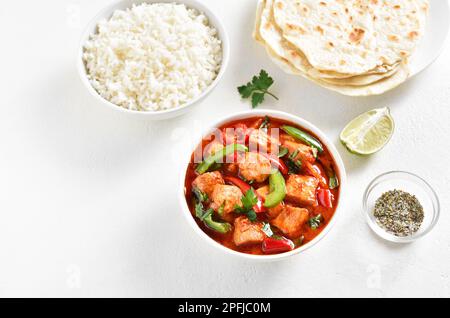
374, 190, 424, 237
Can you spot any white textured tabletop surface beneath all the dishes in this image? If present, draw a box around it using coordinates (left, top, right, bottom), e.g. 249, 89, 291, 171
0, 0, 450, 297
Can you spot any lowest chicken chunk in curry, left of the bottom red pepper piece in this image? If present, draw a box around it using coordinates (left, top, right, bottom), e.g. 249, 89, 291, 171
233, 216, 266, 246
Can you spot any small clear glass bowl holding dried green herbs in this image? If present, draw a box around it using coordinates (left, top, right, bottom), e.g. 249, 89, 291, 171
363, 171, 440, 243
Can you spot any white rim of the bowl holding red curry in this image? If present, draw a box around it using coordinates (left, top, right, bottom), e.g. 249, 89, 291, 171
178, 109, 347, 262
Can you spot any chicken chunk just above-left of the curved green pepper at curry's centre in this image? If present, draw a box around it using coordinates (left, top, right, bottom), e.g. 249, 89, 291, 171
239, 152, 272, 182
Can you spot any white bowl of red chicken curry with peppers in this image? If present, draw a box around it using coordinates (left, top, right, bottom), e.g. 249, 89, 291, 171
179, 110, 347, 260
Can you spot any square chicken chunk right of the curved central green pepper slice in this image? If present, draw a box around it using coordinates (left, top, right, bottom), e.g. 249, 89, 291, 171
286, 174, 319, 206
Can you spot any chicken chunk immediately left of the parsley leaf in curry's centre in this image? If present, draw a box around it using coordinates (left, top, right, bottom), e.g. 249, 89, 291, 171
211, 184, 242, 214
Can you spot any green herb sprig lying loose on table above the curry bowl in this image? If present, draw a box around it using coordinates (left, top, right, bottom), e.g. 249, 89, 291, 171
238, 70, 278, 108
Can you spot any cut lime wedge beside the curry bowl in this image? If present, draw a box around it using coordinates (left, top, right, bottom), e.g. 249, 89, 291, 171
341, 107, 395, 155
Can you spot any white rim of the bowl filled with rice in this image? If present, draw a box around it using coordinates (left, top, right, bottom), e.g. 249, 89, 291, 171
77, 0, 230, 118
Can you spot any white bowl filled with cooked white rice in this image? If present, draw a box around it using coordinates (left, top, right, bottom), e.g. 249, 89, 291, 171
78, 0, 230, 120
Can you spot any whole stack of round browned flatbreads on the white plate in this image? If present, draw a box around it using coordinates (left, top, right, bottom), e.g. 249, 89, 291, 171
254, 0, 429, 96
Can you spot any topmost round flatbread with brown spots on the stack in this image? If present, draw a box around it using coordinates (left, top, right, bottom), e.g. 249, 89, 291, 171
273, 0, 428, 75
